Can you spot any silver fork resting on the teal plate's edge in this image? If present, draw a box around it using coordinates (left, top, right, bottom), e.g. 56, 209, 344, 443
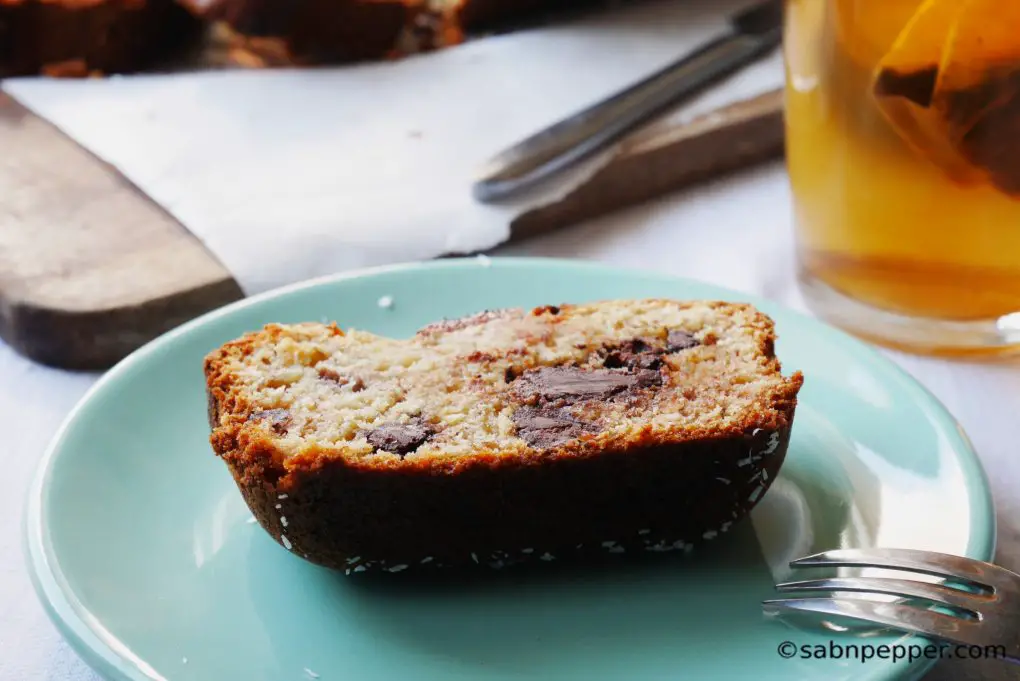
763, 548, 1020, 664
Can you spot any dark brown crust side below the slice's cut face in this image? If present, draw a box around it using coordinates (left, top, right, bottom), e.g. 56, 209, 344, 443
227, 426, 793, 574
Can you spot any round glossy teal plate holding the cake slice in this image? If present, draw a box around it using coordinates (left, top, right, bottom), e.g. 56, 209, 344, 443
26, 259, 995, 681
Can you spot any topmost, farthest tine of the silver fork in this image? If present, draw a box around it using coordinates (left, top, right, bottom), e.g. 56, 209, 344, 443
789, 548, 1003, 590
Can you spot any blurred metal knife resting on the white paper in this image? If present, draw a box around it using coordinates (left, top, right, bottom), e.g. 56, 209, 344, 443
472, 0, 782, 202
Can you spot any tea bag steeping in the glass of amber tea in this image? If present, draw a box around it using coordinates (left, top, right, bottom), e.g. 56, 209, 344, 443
873, 0, 1020, 196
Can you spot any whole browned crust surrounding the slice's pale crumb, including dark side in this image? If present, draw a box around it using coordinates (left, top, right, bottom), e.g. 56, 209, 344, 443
204, 303, 803, 571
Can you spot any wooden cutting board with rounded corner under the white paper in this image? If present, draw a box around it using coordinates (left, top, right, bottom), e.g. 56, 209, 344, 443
0, 91, 783, 370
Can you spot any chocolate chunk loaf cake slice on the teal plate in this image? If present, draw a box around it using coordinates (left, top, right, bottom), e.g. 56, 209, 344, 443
205, 300, 803, 573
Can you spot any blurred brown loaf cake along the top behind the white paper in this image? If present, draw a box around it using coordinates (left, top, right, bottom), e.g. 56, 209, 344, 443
0, 0, 632, 77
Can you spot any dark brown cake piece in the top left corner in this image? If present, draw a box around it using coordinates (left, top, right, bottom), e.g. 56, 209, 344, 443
0, 0, 200, 77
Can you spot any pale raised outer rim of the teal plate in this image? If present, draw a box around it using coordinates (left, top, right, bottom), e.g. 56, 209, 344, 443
21, 256, 998, 681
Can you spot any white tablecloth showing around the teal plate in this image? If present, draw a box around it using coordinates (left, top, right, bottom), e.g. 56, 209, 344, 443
0, 164, 1020, 681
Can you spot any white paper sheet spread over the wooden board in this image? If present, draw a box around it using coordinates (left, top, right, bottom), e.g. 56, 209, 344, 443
3, 0, 783, 294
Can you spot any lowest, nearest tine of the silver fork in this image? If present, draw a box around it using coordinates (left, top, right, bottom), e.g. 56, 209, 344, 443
762, 598, 986, 644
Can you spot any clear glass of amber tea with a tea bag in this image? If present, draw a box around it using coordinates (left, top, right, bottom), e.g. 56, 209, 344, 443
783, 0, 1020, 355
